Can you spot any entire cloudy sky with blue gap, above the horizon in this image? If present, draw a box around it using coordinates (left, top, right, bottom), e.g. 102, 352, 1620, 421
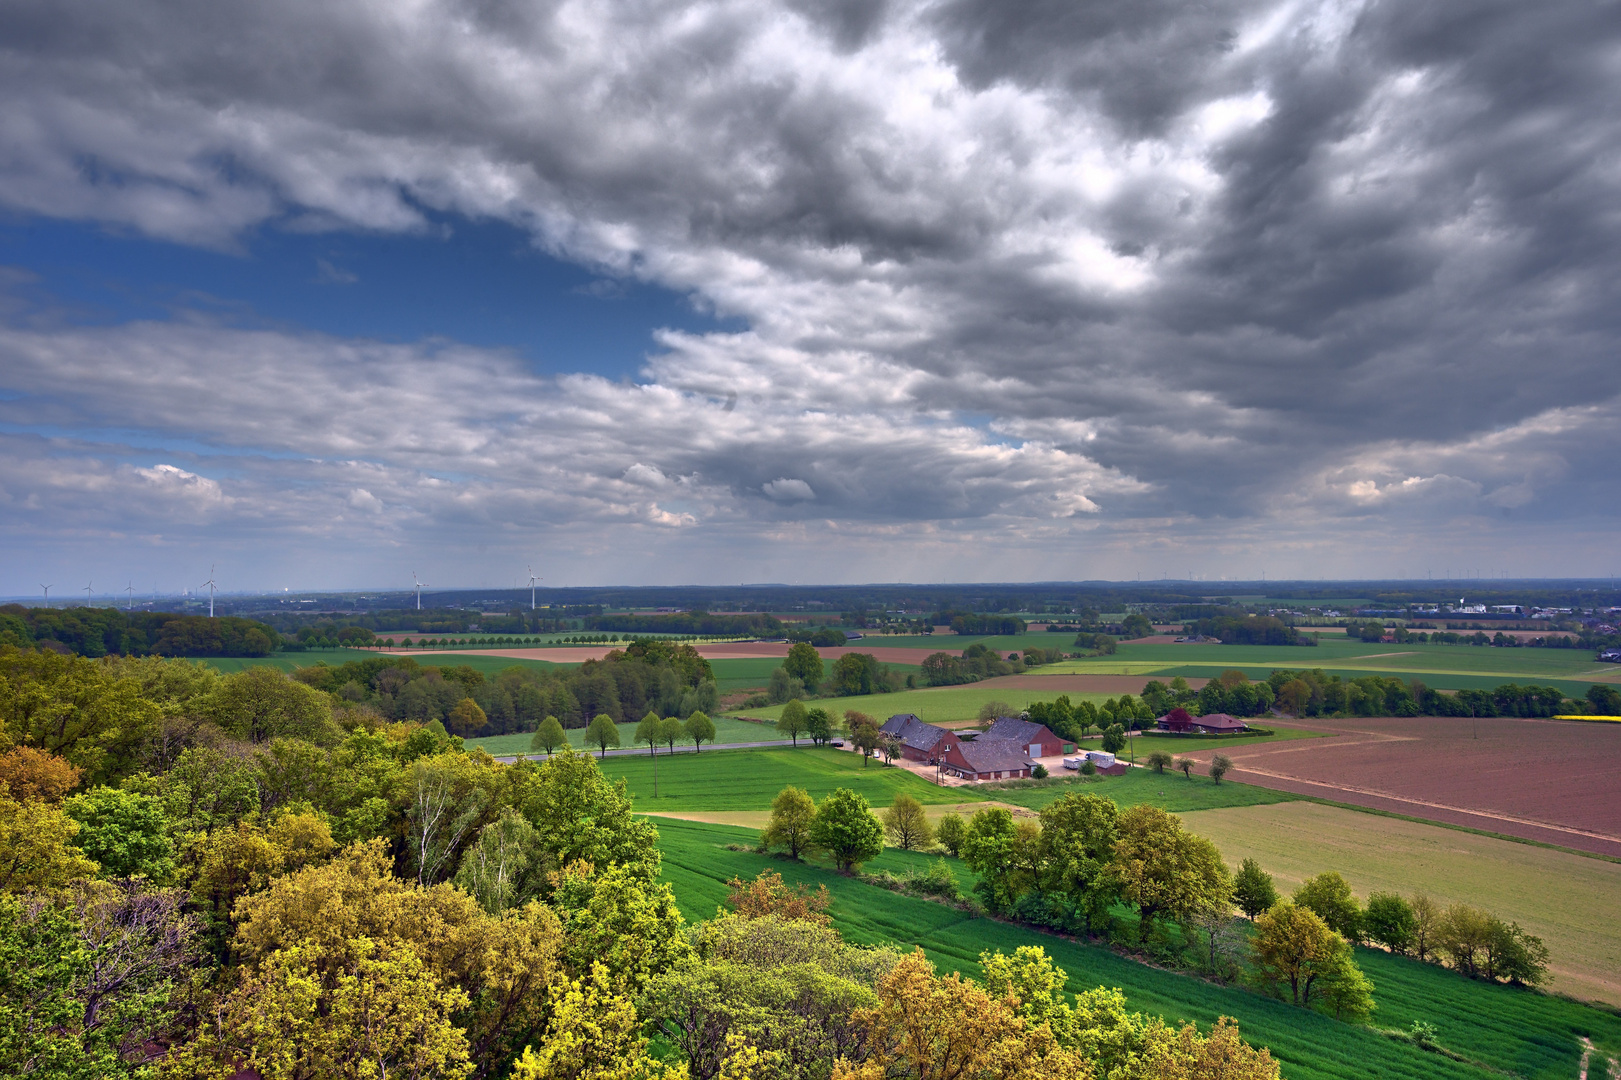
0, 0, 1621, 597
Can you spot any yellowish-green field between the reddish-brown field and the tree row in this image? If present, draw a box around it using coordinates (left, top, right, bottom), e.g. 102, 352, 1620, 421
1183, 803, 1621, 1005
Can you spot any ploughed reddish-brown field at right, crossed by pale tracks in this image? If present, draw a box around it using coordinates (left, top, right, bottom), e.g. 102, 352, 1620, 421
1191, 717, 1621, 856
